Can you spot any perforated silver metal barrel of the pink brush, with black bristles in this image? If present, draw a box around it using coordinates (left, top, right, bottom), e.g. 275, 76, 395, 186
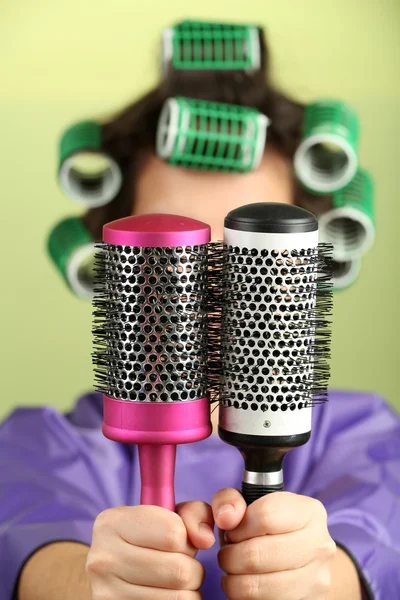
94, 244, 207, 402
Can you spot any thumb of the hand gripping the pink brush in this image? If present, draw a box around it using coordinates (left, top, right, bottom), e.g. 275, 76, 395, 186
176, 500, 215, 550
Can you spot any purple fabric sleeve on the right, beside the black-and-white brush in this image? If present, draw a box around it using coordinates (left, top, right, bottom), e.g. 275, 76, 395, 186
288, 392, 400, 600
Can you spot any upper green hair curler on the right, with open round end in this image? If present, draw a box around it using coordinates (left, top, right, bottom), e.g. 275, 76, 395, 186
294, 100, 359, 195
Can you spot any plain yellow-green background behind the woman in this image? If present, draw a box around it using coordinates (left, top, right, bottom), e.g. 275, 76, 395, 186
0, 0, 400, 416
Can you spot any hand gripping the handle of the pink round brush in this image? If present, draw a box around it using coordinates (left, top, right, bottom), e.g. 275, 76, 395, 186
86, 502, 215, 600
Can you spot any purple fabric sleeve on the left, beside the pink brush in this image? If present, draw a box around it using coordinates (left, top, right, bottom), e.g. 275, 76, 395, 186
0, 394, 129, 600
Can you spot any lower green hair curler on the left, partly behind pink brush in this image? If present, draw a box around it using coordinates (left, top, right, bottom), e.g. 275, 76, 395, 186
47, 217, 99, 298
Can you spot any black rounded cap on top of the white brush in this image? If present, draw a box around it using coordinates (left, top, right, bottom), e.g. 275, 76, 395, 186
225, 202, 318, 233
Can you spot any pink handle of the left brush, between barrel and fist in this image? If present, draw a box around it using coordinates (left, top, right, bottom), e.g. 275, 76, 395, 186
138, 444, 176, 511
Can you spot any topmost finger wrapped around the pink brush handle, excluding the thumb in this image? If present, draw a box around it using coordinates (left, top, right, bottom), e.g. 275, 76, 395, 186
93, 506, 197, 556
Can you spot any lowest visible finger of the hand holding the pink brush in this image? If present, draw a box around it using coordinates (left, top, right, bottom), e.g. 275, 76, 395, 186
91, 579, 201, 600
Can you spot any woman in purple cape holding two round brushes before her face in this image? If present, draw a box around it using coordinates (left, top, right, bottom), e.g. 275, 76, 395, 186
0, 23, 400, 600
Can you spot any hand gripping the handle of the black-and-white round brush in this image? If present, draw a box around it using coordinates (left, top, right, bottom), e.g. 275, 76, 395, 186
212, 489, 336, 600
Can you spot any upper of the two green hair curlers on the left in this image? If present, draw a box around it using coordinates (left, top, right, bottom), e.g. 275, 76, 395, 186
58, 121, 122, 208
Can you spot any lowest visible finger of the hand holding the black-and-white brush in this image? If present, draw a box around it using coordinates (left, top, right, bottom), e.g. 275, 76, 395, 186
221, 563, 331, 600
